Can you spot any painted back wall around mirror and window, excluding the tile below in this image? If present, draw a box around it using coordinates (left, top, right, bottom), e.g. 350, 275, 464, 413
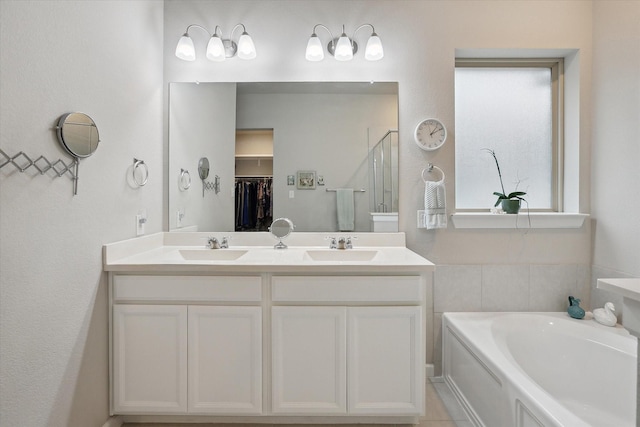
164, 0, 591, 264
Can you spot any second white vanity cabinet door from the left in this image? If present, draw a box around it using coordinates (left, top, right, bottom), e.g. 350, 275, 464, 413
189, 306, 262, 414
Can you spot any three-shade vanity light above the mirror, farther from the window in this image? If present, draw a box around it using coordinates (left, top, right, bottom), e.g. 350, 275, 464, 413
176, 24, 256, 62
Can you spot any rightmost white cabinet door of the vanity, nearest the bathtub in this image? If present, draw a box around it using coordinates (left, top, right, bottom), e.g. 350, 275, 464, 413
348, 307, 425, 415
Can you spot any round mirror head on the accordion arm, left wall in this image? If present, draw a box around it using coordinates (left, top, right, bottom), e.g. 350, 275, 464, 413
58, 113, 100, 158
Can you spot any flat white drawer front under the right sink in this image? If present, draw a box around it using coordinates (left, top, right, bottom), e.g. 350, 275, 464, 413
272, 276, 424, 303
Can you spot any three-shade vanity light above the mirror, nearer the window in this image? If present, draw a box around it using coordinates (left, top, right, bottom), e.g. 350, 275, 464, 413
305, 24, 384, 62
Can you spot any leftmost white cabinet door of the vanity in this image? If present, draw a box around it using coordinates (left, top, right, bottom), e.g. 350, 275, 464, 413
113, 304, 187, 414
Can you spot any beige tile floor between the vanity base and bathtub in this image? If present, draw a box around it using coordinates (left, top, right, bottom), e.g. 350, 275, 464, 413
123, 377, 473, 427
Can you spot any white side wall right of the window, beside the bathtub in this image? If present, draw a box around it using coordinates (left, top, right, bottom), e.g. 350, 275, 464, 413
592, 1, 640, 307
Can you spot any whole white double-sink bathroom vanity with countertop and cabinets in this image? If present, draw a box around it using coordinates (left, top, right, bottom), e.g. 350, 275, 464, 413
104, 233, 434, 424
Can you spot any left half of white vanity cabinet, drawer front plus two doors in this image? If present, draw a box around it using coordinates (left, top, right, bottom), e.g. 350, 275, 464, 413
112, 275, 262, 415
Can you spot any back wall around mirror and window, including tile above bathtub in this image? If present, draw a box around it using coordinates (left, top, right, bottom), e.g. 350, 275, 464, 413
164, 0, 592, 372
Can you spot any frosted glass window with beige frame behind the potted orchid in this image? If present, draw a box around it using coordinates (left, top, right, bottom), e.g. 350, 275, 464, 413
455, 59, 563, 211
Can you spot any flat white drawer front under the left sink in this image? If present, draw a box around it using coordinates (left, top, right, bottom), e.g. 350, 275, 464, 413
113, 275, 262, 302
